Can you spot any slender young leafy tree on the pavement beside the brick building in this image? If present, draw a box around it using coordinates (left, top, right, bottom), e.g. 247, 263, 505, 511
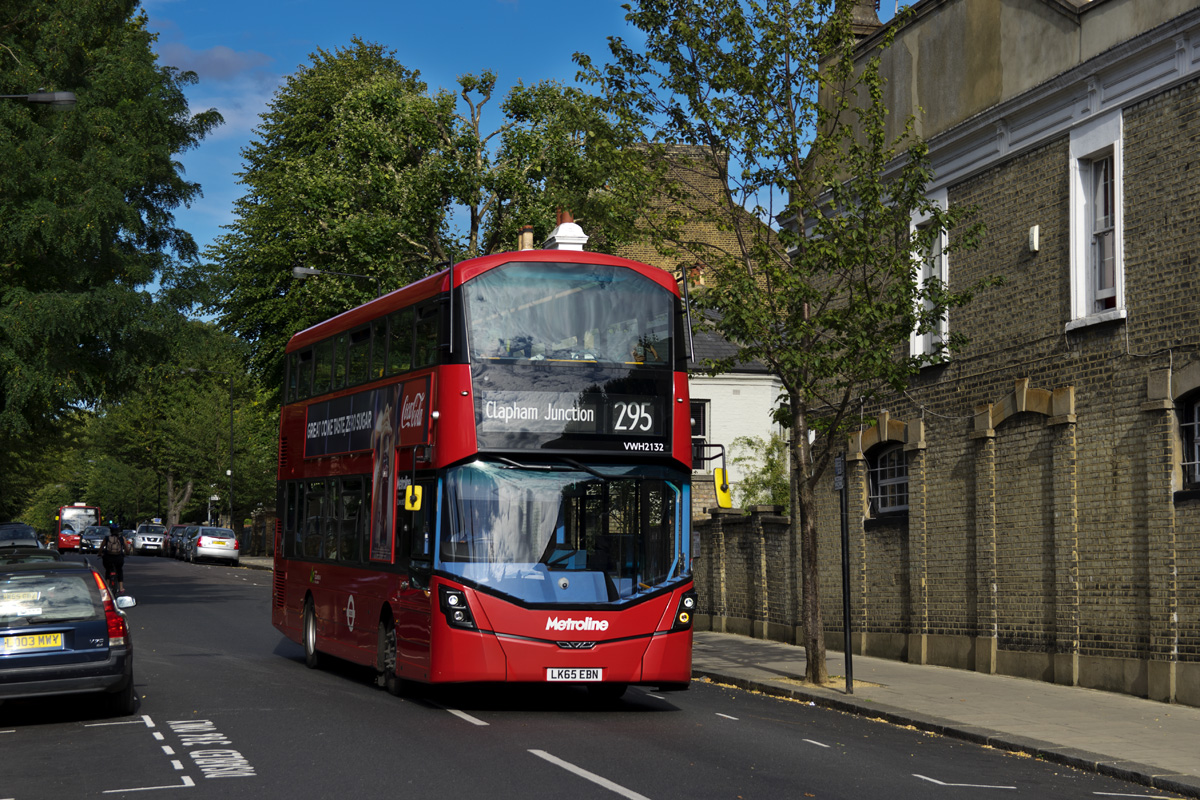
577, 0, 979, 682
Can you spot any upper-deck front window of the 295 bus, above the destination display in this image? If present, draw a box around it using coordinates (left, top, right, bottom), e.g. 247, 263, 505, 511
463, 263, 674, 367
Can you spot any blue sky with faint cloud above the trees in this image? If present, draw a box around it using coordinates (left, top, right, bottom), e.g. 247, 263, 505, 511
143, 0, 895, 260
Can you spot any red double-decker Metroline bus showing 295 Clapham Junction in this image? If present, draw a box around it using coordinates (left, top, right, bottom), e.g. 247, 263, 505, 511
271, 251, 696, 697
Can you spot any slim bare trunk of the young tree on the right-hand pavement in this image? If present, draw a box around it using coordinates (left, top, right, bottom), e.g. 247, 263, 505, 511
790, 395, 829, 684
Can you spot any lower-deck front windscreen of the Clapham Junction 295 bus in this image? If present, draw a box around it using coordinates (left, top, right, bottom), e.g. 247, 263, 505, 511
438, 461, 686, 603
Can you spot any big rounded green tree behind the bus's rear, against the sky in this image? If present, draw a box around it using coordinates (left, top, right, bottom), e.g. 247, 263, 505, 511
196, 40, 451, 398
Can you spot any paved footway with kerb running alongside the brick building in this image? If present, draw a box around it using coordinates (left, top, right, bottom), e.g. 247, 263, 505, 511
234, 555, 1200, 798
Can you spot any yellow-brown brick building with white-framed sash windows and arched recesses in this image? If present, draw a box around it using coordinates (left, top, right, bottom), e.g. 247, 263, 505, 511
697, 0, 1200, 705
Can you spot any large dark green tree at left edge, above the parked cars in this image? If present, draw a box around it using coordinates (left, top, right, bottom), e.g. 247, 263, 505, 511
0, 0, 221, 449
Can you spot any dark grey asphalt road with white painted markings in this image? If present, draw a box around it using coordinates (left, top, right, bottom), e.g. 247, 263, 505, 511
0, 557, 1169, 800
